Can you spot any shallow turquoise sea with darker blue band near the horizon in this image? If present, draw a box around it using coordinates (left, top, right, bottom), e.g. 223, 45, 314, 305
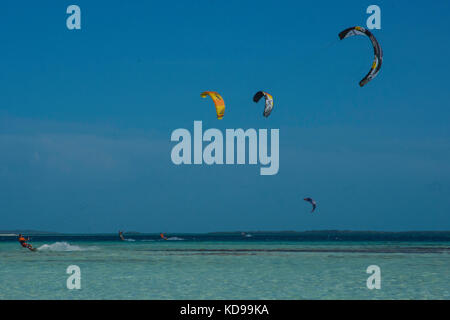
0, 234, 450, 299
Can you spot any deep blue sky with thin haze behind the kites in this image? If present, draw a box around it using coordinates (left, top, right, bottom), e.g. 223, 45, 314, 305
0, 0, 450, 233
